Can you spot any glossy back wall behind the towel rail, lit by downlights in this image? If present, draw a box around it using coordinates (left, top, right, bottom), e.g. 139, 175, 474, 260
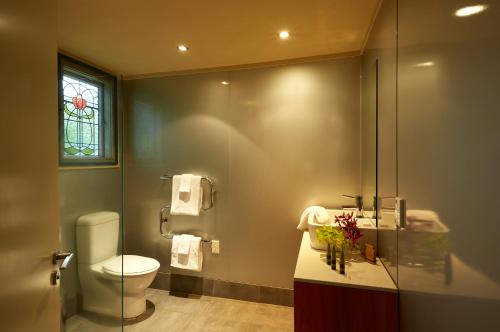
125, 57, 360, 288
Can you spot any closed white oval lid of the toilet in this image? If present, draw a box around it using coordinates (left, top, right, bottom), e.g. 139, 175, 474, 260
102, 255, 160, 276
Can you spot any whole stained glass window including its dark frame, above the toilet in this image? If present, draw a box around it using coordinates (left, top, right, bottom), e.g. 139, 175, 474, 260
58, 54, 118, 167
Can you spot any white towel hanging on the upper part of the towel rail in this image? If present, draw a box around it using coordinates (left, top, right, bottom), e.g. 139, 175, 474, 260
170, 174, 203, 216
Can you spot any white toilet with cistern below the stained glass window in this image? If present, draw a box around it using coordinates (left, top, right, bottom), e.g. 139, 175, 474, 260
76, 211, 160, 318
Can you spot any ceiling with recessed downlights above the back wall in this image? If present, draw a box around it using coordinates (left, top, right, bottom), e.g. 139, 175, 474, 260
58, 0, 379, 77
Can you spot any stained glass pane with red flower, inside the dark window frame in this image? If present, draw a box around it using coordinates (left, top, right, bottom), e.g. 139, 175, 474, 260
62, 75, 103, 157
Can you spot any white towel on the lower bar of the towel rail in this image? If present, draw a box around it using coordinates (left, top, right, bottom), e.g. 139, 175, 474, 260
170, 235, 203, 272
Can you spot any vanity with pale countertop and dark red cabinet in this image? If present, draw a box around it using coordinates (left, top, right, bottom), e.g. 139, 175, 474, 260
293, 232, 398, 332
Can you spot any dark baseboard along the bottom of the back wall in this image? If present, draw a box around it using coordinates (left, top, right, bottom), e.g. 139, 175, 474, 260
151, 272, 293, 307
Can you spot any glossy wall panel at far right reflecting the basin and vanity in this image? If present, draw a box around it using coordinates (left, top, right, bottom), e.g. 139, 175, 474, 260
397, 0, 500, 331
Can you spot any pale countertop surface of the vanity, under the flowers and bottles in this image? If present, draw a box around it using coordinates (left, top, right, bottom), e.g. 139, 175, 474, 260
294, 232, 398, 292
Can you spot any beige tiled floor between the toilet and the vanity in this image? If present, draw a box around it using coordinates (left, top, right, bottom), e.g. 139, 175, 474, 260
66, 289, 293, 332
